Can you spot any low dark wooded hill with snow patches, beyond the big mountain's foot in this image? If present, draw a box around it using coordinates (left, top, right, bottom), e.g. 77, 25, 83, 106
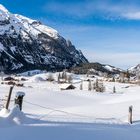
71, 63, 124, 75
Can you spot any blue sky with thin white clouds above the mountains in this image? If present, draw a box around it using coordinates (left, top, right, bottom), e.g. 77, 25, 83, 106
1, 0, 140, 69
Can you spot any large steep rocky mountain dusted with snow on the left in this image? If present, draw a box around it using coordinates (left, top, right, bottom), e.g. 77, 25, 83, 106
0, 5, 88, 73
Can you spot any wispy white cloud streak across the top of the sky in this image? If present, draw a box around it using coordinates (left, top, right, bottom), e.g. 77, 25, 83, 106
43, 0, 140, 20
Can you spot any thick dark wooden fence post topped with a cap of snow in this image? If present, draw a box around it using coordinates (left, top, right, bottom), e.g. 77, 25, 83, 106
15, 91, 25, 111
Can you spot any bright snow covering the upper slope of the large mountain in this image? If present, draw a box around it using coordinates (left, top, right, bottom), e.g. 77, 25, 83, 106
0, 4, 59, 39
